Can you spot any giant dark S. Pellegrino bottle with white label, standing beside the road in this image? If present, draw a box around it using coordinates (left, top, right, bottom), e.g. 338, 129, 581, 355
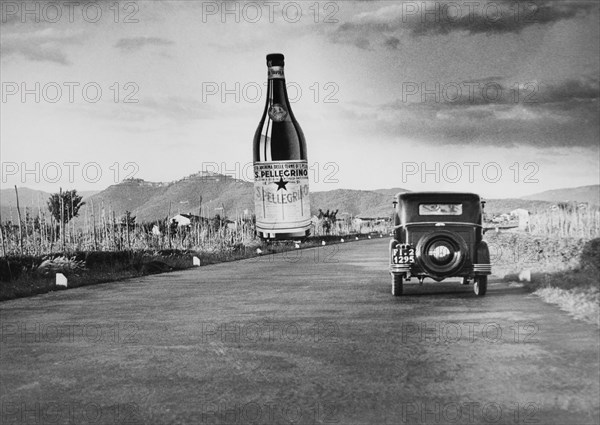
253, 54, 311, 240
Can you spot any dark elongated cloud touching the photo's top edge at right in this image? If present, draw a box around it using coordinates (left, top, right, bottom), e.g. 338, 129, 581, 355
330, 0, 598, 49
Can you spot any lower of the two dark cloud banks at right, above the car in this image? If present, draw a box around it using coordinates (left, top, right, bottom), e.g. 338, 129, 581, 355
345, 78, 600, 148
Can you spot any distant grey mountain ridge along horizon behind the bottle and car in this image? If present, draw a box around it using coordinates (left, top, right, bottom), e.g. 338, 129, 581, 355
0, 173, 598, 223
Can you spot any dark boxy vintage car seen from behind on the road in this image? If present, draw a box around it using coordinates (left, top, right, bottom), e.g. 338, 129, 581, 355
390, 192, 492, 296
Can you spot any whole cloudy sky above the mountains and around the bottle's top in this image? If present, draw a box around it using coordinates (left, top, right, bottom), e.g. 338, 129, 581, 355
0, 0, 600, 197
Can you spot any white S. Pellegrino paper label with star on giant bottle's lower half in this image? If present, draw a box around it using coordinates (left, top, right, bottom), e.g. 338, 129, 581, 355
254, 161, 310, 233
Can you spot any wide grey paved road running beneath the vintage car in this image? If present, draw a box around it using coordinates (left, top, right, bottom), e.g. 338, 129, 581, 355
0, 240, 600, 424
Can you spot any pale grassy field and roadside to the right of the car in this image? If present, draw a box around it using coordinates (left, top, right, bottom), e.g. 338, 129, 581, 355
486, 209, 600, 326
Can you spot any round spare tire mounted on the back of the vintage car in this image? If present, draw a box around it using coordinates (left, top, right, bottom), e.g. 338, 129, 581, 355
416, 230, 468, 278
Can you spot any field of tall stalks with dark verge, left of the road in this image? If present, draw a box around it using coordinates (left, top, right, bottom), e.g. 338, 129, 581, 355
0, 210, 389, 301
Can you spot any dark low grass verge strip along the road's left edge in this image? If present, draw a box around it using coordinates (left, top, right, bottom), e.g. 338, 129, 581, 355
0, 234, 379, 301
